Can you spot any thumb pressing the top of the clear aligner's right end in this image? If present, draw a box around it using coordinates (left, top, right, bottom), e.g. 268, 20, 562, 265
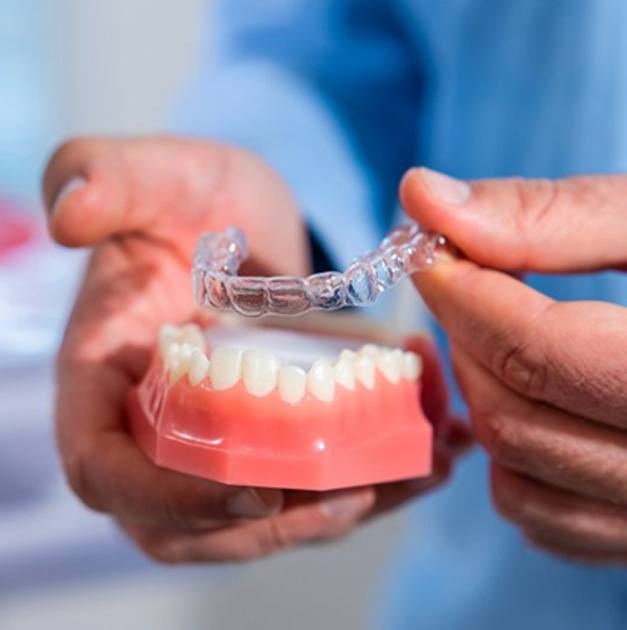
400, 168, 627, 272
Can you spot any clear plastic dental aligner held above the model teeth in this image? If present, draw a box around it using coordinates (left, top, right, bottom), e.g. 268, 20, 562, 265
192, 223, 446, 317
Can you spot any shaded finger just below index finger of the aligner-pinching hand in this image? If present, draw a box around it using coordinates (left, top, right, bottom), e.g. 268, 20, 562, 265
453, 347, 627, 505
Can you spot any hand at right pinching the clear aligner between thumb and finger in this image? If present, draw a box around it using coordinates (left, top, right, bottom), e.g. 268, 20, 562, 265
401, 169, 627, 564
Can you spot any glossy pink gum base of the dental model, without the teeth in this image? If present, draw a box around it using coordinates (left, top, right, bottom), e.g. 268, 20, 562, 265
130, 315, 432, 490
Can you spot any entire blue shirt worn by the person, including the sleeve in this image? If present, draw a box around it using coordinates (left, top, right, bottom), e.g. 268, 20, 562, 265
176, 0, 627, 630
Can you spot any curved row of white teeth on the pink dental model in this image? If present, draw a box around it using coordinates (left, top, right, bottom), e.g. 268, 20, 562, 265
158, 324, 422, 404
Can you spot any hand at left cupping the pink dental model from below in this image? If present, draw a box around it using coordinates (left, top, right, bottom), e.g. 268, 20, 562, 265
44, 138, 472, 562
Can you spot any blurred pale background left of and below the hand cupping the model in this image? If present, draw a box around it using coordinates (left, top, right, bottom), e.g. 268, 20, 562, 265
0, 0, 403, 630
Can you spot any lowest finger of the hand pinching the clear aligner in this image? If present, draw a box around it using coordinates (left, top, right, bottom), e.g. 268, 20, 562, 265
491, 464, 627, 554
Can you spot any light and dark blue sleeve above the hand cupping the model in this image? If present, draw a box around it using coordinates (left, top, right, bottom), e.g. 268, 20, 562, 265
174, 0, 421, 265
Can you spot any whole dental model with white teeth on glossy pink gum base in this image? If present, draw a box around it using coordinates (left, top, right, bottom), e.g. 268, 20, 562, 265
130, 318, 432, 490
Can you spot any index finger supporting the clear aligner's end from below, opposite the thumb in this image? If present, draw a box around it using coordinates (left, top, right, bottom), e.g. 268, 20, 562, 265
414, 260, 627, 427
